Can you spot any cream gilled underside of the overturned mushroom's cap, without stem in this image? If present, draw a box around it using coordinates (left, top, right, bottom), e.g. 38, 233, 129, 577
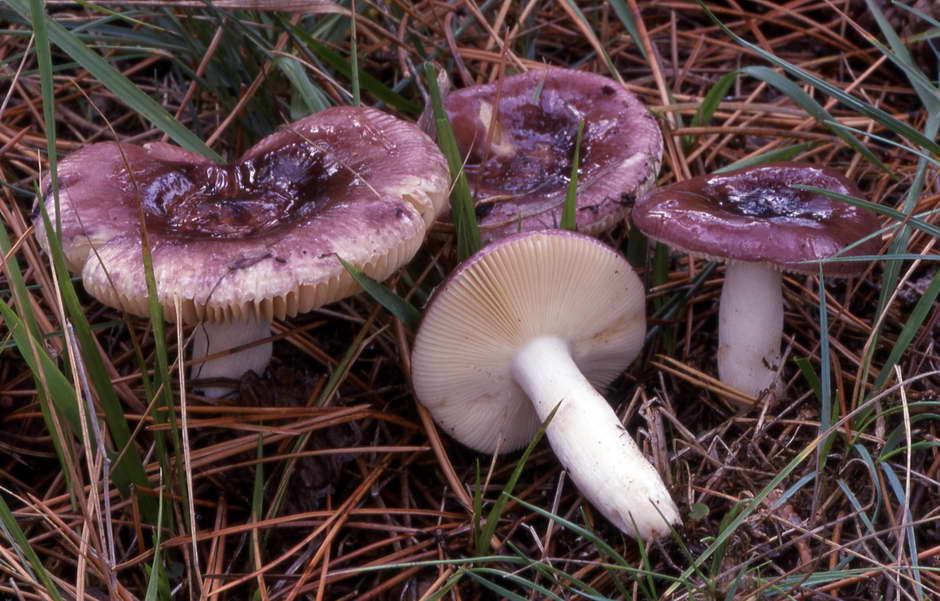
412, 230, 646, 453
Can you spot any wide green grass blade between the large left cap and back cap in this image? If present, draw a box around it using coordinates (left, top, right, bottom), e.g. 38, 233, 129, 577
424, 63, 483, 261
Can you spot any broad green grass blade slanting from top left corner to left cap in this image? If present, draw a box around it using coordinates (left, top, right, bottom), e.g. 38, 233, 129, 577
7, 0, 222, 162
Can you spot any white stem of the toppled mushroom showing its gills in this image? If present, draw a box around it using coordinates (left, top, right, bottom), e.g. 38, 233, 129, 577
513, 336, 679, 539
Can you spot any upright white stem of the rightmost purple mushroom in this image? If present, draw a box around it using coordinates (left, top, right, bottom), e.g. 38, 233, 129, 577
718, 263, 783, 397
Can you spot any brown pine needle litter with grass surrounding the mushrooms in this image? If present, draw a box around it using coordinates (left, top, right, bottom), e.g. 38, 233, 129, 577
0, 0, 940, 601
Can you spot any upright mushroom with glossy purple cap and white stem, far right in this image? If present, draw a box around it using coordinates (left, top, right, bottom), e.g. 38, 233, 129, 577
632, 162, 880, 397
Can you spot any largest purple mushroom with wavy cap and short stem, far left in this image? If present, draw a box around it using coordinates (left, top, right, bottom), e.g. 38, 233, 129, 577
43, 107, 450, 395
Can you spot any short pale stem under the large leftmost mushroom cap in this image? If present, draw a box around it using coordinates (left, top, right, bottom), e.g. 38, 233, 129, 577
191, 320, 271, 398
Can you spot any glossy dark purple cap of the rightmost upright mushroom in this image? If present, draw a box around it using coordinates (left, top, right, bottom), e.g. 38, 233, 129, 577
632, 162, 880, 276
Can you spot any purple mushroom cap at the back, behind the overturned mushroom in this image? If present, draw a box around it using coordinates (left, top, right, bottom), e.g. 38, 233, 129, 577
419, 68, 663, 241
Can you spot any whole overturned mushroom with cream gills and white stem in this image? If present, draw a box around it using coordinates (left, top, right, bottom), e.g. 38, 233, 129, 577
412, 230, 679, 538
